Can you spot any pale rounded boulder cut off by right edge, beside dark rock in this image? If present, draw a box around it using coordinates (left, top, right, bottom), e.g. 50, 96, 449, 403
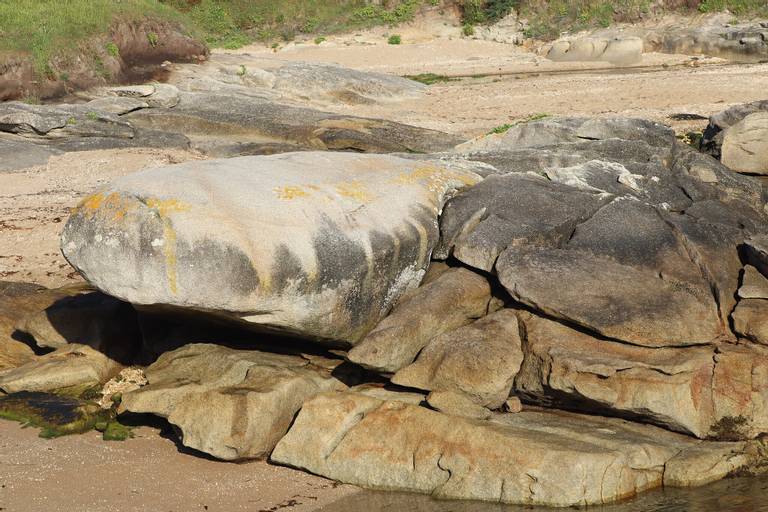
721, 112, 768, 175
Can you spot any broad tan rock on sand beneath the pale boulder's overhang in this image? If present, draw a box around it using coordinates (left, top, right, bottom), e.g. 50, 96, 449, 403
121, 344, 346, 460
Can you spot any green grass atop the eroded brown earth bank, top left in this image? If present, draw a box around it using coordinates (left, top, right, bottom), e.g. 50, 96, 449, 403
0, 0, 181, 76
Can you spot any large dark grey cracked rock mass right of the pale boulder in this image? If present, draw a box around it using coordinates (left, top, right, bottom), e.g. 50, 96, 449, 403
435, 118, 768, 347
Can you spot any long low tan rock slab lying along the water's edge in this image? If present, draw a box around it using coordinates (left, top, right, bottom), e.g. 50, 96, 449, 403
271, 393, 760, 506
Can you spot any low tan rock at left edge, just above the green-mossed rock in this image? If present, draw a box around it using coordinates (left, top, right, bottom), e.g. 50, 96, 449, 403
0, 343, 122, 393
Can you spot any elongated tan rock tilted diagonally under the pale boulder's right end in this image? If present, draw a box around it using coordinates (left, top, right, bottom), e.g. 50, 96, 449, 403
348, 268, 491, 373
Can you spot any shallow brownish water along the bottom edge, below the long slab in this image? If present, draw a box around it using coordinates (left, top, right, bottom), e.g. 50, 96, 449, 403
320, 476, 768, 512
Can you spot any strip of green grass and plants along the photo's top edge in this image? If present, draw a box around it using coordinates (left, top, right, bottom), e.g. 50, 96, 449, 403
0, 0, 768, 86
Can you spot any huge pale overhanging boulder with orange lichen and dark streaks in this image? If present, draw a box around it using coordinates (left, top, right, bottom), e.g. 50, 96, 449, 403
61, 152, 480, 344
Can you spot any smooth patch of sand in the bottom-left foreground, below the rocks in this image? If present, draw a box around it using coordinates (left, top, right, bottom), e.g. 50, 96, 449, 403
0, 421, 359, 512
